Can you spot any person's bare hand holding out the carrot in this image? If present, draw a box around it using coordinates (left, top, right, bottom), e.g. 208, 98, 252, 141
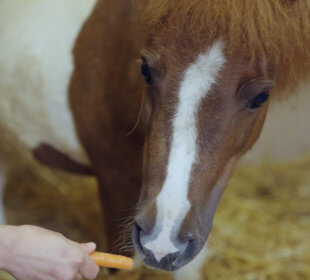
0, 226, 99, 280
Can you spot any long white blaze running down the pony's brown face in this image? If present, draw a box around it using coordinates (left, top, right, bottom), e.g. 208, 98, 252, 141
144, 41, 225, 261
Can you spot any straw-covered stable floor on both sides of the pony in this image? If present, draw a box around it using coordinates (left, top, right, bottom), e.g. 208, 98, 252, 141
0, 153, 310, 280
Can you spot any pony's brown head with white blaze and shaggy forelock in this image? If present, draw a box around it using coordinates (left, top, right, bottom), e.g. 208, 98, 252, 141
133, 0, 310, 271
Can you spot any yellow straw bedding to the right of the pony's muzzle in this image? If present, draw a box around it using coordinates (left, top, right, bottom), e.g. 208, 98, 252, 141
205, 157, 310, 280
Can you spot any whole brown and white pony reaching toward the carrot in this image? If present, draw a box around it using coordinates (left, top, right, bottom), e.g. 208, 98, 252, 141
0, 0, 310, 280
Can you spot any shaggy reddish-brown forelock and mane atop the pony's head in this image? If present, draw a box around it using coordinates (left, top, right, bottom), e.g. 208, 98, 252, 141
132, 0, 310, 95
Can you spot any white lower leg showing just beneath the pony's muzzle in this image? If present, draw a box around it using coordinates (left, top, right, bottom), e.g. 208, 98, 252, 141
173, 244, 207, 280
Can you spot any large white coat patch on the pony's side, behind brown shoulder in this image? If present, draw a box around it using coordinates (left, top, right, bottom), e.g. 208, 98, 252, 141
0, 0, 96, 160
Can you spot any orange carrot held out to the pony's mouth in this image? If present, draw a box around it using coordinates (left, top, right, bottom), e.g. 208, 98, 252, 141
90, 252, 133, 270
